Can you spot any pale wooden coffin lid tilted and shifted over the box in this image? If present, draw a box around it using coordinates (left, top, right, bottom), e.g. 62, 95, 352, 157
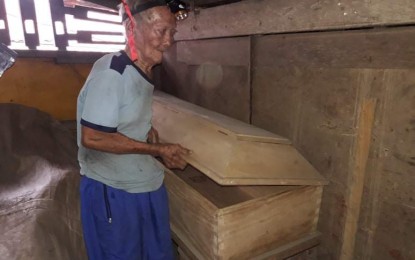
153, 91, 326, 185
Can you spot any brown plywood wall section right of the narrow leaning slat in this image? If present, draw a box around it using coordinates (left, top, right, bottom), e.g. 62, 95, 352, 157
362, 70, 415, 259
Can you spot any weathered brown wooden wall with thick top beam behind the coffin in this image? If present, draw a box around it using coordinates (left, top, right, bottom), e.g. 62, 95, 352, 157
161, 0, 415, 259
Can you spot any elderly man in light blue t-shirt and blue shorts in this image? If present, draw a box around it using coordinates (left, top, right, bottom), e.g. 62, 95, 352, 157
77, 0, 189, 260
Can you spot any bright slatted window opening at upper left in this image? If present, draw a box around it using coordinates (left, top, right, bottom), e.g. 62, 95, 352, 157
0, 0, 125, 56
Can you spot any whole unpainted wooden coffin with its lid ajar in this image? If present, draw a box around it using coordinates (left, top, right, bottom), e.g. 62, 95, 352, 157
153, 92, 326, 259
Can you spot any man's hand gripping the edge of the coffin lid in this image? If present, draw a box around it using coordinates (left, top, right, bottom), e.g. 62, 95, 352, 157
159, 144, 191, 170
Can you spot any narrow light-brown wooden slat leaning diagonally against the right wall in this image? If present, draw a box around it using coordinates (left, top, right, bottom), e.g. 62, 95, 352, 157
340, 99, 376, 260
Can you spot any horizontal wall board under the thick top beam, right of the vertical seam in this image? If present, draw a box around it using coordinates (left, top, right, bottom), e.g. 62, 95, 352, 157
253, 27, 415, 69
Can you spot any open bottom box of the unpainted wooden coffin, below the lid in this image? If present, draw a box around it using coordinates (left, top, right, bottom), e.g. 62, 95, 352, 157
166, 168, 322, 260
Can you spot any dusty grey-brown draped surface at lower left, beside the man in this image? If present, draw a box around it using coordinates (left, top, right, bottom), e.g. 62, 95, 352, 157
0, 104, 86, 260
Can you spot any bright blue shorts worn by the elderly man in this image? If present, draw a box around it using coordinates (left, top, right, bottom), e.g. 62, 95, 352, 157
80, 176, 173, 260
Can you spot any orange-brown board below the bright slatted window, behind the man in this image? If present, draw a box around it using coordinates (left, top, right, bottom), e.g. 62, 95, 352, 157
0, 58, 92, 120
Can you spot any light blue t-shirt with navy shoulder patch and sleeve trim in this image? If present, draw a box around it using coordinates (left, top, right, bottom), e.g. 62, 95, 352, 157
77, 52, 164, 193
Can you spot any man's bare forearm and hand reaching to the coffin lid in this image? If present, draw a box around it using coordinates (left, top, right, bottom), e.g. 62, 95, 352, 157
81, 126, 190, 169
